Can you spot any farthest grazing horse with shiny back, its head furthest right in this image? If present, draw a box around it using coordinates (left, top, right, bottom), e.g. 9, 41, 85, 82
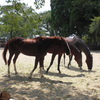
64, 35, 93, 70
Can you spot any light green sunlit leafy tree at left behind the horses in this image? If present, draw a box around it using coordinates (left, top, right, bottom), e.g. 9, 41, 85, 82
0, 0, 41, 38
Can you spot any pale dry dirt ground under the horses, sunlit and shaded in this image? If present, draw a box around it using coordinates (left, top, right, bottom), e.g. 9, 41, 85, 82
0, 48, 100, 100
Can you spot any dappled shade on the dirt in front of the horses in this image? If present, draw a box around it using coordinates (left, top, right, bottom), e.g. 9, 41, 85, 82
0, 72, 97, 100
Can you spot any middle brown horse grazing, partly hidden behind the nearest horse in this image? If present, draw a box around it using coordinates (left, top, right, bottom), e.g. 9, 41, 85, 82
46, 38, 82, 73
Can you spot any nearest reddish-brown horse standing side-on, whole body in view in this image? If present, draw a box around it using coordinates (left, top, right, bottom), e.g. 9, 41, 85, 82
3, 37, 70, 78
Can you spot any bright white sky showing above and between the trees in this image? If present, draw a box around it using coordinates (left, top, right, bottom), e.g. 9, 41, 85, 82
0, 0, 51, 13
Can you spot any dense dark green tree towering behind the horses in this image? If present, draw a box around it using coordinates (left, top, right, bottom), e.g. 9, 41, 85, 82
51, 0, 100, 37
